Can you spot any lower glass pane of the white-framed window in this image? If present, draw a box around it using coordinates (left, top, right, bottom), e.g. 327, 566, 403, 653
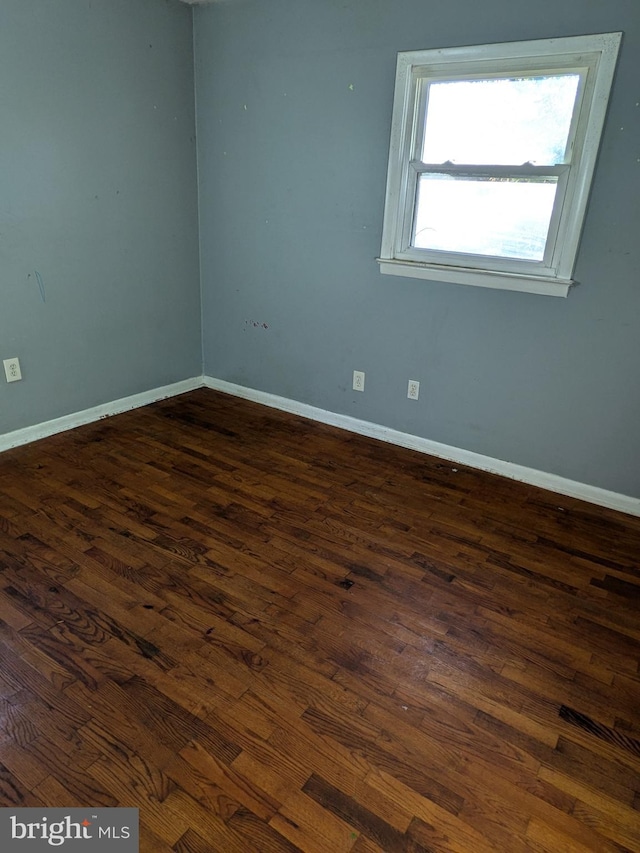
412, 173, 557, 261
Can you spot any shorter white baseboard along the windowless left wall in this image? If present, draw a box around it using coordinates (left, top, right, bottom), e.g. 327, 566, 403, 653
0, 376, 204, 452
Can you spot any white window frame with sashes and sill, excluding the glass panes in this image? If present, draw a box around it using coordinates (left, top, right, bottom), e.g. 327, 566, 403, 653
377, 33, 622, 296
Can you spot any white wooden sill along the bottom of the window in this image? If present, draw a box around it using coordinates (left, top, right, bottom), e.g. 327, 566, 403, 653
376, 258, 574, 297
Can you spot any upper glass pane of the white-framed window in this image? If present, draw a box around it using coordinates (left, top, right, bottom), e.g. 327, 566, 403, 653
422, 74, 580, 166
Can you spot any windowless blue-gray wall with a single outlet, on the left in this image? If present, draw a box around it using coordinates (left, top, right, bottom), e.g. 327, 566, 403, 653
0, 0, 201, 433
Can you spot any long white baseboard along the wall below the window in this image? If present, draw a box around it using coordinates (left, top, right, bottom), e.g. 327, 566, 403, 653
203, 376, 640, 516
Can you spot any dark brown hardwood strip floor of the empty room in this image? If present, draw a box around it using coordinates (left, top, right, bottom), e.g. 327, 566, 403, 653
0, 390, 640, 853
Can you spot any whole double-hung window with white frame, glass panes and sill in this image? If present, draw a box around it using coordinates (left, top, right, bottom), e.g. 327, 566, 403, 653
378, 33, 622, 296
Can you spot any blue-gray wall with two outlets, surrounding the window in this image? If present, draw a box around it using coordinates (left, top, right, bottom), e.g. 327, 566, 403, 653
195, 0, 640, 497
